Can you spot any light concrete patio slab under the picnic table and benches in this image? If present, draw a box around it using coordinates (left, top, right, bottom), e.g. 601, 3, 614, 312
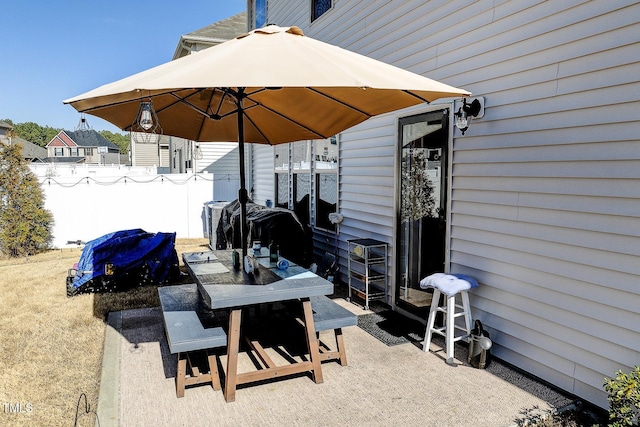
98, 301, 570, 427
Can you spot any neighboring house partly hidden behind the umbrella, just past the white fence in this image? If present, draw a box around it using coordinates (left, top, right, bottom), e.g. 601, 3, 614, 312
131, 12, 247, 200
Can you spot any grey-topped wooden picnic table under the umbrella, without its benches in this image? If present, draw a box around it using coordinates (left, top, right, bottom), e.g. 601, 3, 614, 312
183, 250, 336, 402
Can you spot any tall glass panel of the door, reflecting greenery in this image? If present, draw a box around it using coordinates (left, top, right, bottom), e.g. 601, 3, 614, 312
395, 110, 448, 319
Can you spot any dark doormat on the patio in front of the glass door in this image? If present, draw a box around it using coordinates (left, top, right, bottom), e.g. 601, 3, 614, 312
358, 310, 425, 346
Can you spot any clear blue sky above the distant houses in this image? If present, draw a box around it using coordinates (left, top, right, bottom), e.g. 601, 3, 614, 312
0, 0, 247, 133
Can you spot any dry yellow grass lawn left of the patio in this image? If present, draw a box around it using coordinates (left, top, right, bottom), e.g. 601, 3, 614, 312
0, 239, 207, 426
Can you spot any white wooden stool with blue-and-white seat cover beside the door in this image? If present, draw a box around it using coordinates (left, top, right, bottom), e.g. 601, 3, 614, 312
420, 273, 478, 365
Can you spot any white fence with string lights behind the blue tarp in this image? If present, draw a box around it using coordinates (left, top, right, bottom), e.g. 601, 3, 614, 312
30, 165, 220, 248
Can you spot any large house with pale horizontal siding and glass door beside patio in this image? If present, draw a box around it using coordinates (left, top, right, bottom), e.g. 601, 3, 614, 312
248, 0, 640, 407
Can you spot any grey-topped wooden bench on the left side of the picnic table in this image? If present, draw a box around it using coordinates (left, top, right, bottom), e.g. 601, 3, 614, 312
158, 284, 227, 397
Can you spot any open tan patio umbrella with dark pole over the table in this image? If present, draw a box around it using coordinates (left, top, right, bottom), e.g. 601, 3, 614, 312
64, 25, 470, 255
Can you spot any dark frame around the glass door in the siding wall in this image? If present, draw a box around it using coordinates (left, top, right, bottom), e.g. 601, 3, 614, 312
389, 101, 454, 324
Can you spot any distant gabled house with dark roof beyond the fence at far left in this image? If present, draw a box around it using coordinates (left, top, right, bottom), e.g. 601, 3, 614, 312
46, 129, 120, 165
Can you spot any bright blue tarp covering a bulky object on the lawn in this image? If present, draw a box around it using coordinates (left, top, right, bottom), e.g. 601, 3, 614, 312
67, 228, 178, 295
